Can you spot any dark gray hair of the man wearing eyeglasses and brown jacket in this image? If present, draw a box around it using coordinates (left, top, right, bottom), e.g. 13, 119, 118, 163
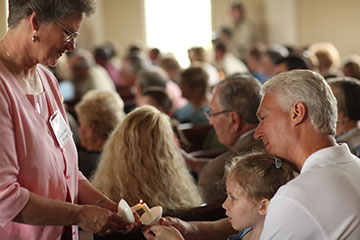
216, 74, 261, 124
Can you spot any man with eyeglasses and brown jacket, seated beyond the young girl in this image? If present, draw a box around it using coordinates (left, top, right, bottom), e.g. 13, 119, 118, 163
198, 74, 261, 203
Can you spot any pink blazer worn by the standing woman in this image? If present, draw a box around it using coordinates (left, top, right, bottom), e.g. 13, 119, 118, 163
0, 62, 85, 239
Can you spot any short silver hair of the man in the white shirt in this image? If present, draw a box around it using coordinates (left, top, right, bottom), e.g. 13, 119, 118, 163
261, 70, 337, 135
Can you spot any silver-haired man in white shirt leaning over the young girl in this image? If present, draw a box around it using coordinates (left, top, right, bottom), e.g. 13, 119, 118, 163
254, 70, 360, 239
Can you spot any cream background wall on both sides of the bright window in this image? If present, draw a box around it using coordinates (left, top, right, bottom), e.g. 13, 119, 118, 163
0, 0, 360, 56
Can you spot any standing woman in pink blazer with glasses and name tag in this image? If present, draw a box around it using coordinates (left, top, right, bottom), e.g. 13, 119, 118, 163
0, 0, 133, 240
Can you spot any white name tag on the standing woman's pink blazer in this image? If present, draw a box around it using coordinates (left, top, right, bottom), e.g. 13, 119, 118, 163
49, 110, 72, 148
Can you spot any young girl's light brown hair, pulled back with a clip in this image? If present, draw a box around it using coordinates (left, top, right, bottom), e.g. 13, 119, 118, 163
226, 152, 294, 204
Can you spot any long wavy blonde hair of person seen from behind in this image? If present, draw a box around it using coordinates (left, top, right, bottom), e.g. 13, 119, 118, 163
92, 105, 202, 212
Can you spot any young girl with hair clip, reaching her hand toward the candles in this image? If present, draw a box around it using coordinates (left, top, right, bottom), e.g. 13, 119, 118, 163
145, 152, 294, 240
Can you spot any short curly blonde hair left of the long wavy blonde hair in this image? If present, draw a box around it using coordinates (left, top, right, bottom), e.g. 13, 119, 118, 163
75, 90, 125, 140
